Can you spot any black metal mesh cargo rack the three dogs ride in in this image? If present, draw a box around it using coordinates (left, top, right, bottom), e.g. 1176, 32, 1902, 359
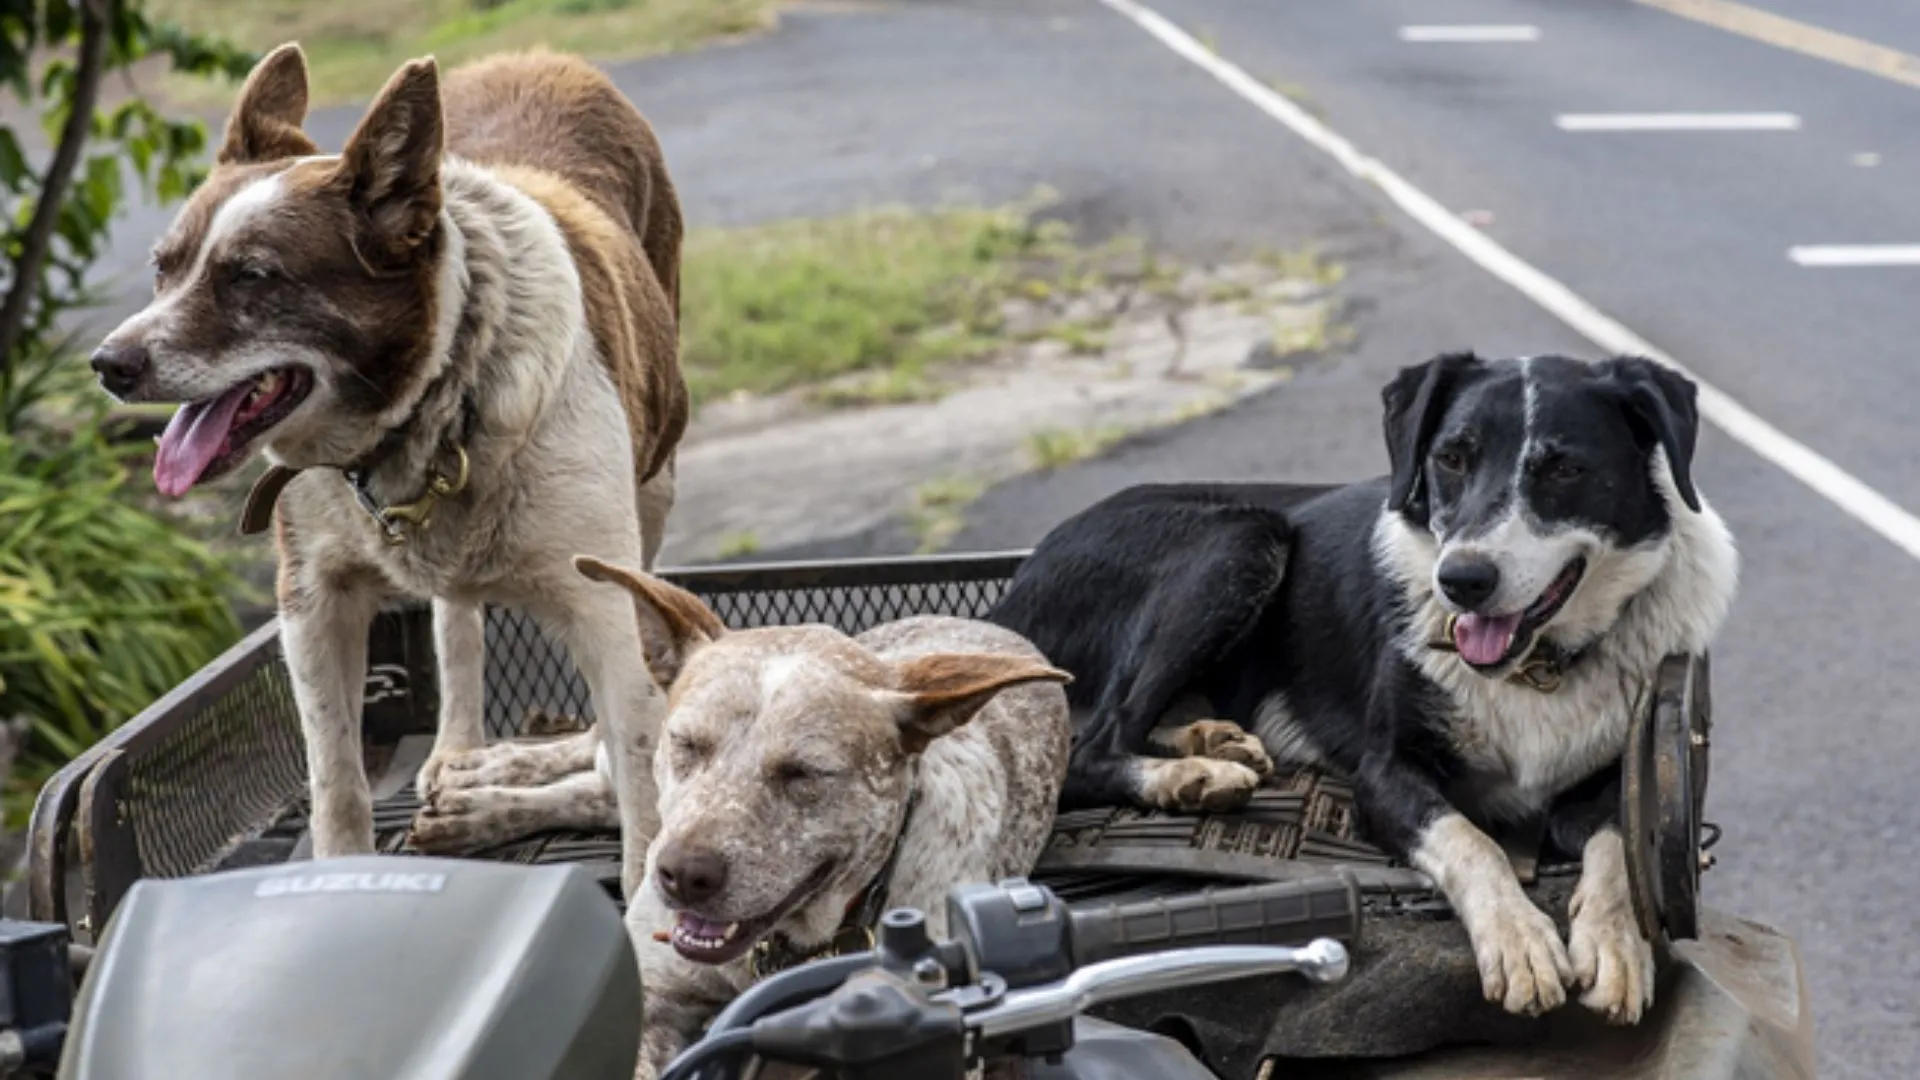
29, 552, 1459, 936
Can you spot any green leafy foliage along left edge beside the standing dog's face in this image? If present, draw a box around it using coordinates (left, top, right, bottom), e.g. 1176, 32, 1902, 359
0, 0, 253, 821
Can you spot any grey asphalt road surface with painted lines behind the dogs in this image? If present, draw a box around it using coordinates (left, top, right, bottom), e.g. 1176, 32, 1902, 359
82, 0, 1920, 1080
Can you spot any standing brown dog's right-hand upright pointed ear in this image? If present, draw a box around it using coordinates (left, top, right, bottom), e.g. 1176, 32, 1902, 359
338, 56, 445, 265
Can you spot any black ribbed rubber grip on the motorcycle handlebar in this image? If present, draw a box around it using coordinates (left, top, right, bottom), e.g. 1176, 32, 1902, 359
1071, 871, 1359, 967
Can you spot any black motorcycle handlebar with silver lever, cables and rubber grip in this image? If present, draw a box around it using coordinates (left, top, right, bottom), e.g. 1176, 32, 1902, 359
662, 872, 1361, 1080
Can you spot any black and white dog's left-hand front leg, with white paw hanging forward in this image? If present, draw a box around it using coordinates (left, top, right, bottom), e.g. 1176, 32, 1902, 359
1354, 753, 1572, 1017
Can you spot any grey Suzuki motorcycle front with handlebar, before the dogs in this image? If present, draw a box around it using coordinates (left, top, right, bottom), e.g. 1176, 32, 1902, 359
22, 855, 1359, 1080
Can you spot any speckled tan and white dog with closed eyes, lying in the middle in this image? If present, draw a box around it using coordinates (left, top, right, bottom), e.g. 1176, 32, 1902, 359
417, 557, 1071, 1078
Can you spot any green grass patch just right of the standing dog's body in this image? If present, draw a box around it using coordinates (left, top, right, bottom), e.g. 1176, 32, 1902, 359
680, 206, 1098, 404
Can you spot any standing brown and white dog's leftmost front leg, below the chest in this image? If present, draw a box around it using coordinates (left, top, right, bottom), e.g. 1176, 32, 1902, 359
280, 584, 378, 859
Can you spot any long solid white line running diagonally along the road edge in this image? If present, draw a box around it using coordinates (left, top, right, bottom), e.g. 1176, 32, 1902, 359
1100, 0, 1920, 559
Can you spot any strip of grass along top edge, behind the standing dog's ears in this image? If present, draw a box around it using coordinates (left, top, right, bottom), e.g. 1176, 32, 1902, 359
146, 0, 774, 104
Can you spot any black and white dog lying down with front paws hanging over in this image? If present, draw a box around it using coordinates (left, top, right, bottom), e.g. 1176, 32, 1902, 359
991, 354, 1738, 1022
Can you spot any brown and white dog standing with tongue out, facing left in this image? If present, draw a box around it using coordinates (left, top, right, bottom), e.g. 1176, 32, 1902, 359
92, 44, 687, 869
